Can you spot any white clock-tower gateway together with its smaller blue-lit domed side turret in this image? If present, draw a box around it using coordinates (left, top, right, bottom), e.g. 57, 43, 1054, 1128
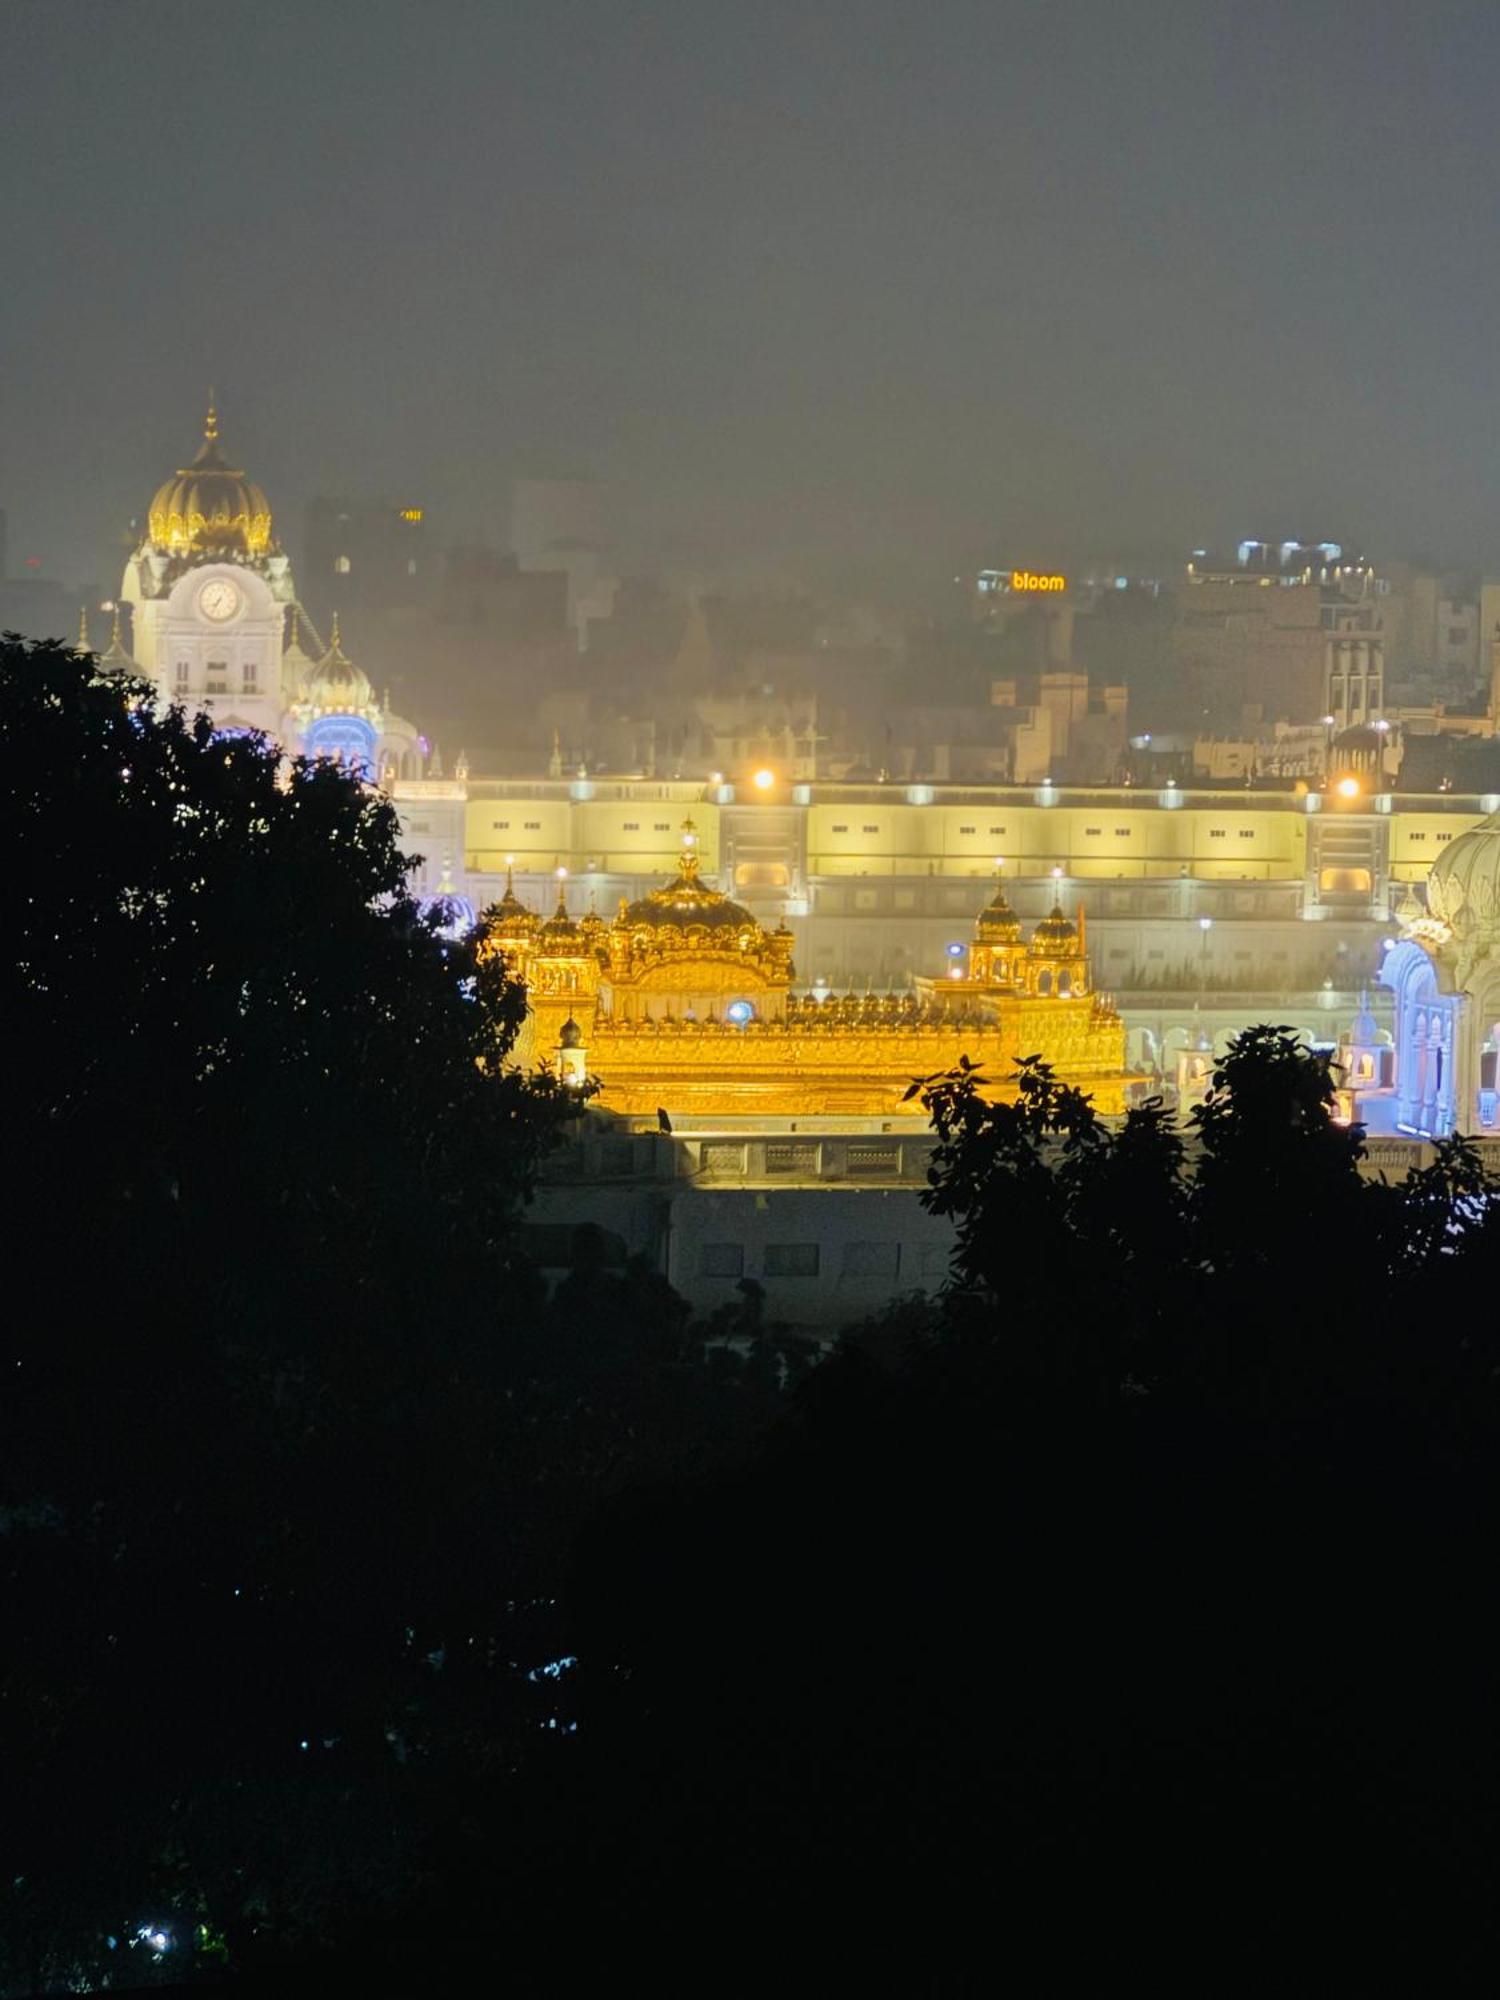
119, 400, 428, 782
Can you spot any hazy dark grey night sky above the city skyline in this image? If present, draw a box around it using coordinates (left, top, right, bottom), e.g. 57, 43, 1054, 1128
0, 0, 1500, 588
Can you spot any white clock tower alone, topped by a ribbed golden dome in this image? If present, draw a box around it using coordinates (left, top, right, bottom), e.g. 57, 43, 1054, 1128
120, 400, 296, 736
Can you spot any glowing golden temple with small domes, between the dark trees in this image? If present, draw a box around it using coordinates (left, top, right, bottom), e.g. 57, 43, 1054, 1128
484, 822, 1130, 1118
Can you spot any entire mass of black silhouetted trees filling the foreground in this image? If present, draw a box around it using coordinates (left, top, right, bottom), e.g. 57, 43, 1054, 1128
0, 646, 1500, 1994
